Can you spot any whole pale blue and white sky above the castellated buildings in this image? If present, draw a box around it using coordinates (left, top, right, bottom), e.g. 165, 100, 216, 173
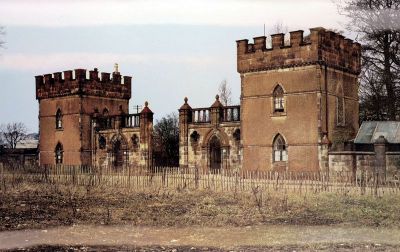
0, 0, 345, 132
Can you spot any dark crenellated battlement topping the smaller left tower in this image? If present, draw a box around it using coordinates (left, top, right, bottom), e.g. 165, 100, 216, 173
35, 68, 132, 100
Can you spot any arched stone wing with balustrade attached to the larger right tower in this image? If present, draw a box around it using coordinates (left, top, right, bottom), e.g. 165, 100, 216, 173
179, 96, 241, 171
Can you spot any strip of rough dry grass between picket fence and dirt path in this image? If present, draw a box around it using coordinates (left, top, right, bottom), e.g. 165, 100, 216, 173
0, 183, 400, 230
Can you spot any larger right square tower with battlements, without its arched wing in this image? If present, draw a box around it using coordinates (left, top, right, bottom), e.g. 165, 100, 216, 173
237, 28, 361, 171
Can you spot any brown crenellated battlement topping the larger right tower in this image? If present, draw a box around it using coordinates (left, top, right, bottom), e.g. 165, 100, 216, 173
236, 27, 361, 75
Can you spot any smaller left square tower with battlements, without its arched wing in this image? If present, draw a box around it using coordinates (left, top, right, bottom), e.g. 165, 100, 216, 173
35, 68, 131, 165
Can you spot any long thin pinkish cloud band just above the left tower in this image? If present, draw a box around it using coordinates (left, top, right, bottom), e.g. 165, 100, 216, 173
0, 53, 225, 73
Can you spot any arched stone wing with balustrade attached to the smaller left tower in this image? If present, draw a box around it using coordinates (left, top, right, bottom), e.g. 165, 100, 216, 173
93, 102, 153, 171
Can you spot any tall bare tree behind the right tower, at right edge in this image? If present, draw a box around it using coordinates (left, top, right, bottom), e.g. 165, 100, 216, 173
337, 0, 400, 120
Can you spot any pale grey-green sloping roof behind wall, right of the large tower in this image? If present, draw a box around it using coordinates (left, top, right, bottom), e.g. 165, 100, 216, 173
354, 121, 400, 144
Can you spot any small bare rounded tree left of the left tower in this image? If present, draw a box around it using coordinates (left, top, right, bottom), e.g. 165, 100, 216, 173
0, 122, 27, 149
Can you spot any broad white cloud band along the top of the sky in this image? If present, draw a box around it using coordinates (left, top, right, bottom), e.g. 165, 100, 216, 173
0, 0, 338, 27
